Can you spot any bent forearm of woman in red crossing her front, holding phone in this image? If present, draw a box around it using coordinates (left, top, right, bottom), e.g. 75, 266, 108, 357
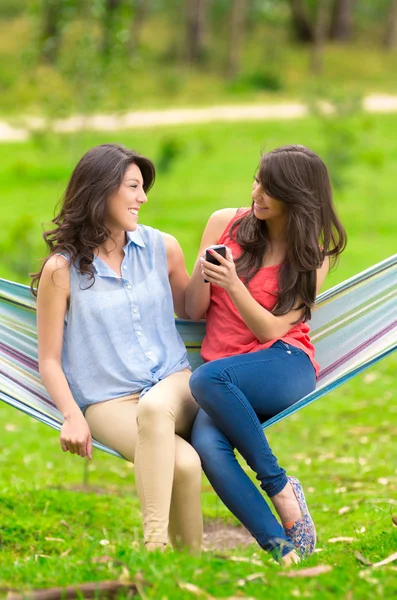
203, 248, 329, 343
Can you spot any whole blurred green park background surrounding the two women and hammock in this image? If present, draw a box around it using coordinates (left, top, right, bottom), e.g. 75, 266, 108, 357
0, 0, 397, 600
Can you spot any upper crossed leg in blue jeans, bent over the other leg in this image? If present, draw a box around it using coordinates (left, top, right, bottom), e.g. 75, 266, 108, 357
190, 343, 315, 497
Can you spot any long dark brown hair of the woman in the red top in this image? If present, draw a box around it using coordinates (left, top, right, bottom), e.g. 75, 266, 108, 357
230, 145, 347, 322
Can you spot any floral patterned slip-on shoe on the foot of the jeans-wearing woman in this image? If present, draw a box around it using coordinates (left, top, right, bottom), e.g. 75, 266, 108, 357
284, 477, 316, 558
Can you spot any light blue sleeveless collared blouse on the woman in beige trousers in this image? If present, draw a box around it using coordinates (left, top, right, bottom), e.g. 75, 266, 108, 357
62, 225, 189, 411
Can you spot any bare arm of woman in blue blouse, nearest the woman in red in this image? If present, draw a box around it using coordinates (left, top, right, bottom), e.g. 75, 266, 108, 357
161, 232, 190, 319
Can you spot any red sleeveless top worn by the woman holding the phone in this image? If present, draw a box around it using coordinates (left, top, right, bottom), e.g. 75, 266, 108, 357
201, 209, 320, 375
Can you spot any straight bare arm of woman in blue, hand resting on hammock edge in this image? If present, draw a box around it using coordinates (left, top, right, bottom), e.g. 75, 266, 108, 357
37, 255, 92, 458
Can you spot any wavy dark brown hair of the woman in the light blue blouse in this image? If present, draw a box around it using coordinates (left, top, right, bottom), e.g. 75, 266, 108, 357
31, 144, 156, 295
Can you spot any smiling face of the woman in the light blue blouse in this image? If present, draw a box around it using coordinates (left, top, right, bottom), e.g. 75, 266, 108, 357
106, 164, 147, 233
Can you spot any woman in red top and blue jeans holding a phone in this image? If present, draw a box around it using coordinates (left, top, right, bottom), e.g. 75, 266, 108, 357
186, 146, 346, 564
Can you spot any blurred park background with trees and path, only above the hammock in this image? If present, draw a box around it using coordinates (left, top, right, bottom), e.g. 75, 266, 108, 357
0, 0, 397, 285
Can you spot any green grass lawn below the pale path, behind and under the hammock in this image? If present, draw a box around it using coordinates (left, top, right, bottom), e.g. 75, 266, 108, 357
0, 116, 397, 600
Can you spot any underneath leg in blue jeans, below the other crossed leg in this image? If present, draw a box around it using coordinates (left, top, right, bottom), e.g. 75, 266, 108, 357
192, 410, 293, 556
